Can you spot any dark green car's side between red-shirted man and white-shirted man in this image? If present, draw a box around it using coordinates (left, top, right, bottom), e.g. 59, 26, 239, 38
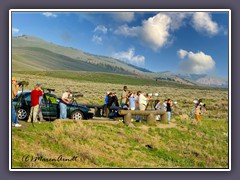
41, 93, 58, 119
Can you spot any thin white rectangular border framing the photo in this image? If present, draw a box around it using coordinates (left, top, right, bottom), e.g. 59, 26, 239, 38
9, 9, 232, 171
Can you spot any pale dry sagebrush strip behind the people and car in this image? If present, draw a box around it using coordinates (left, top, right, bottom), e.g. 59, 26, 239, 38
13, 73, 228, 120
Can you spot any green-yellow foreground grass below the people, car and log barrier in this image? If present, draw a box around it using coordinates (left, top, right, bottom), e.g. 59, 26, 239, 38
12, 119, 228, 168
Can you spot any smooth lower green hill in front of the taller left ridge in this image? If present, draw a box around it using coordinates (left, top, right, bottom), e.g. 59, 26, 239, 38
12, 47, 129, 72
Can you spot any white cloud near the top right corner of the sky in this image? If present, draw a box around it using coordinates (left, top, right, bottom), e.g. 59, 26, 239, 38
192, 12, 220, 36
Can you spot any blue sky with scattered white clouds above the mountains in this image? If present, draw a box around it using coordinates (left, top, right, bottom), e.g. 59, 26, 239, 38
11, 10, 229, 78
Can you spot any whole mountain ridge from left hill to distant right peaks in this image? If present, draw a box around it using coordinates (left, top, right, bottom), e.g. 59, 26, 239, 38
12, 35, 228, 87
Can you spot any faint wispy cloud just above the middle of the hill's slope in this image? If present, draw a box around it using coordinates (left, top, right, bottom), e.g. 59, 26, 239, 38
113, 48, 145, 65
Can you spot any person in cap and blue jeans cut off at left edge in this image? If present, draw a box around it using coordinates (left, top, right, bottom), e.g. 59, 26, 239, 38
12, 77, 22, 127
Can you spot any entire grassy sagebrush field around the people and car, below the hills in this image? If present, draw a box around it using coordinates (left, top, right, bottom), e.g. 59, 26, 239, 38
12, 71, 229, 168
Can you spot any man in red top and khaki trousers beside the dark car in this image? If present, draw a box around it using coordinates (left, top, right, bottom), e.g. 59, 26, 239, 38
28, 83, 43, 122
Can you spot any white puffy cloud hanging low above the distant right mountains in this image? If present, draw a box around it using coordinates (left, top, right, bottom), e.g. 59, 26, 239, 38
178, 49, 215, 74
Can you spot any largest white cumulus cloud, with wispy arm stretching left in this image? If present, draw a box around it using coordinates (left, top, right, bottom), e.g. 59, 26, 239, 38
114, 12, 191, 50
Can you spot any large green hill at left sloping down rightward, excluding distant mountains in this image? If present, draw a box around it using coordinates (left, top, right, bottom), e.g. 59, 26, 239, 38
12, 36, 143, 74
